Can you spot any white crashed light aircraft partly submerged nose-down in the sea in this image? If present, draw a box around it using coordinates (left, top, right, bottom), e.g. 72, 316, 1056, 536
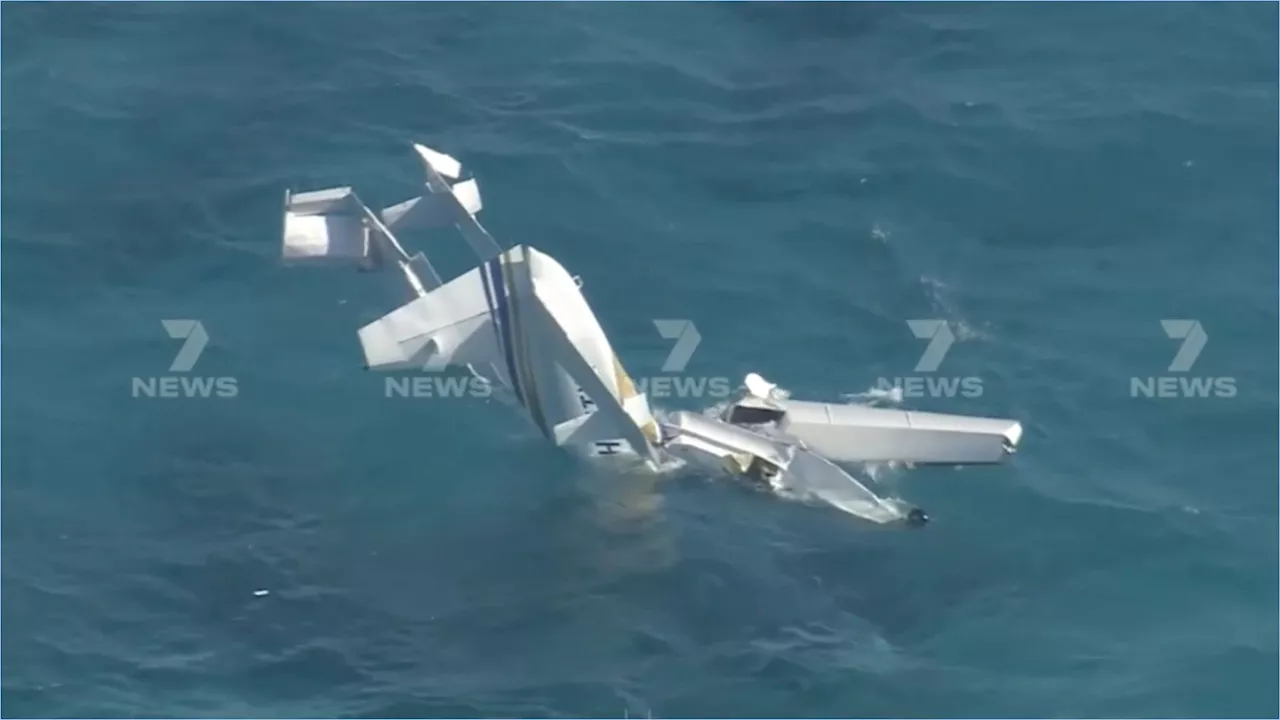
282, 145, 1023, 525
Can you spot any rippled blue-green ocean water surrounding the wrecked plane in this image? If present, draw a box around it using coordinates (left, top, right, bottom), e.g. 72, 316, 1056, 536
0, 3, 1280, 717
